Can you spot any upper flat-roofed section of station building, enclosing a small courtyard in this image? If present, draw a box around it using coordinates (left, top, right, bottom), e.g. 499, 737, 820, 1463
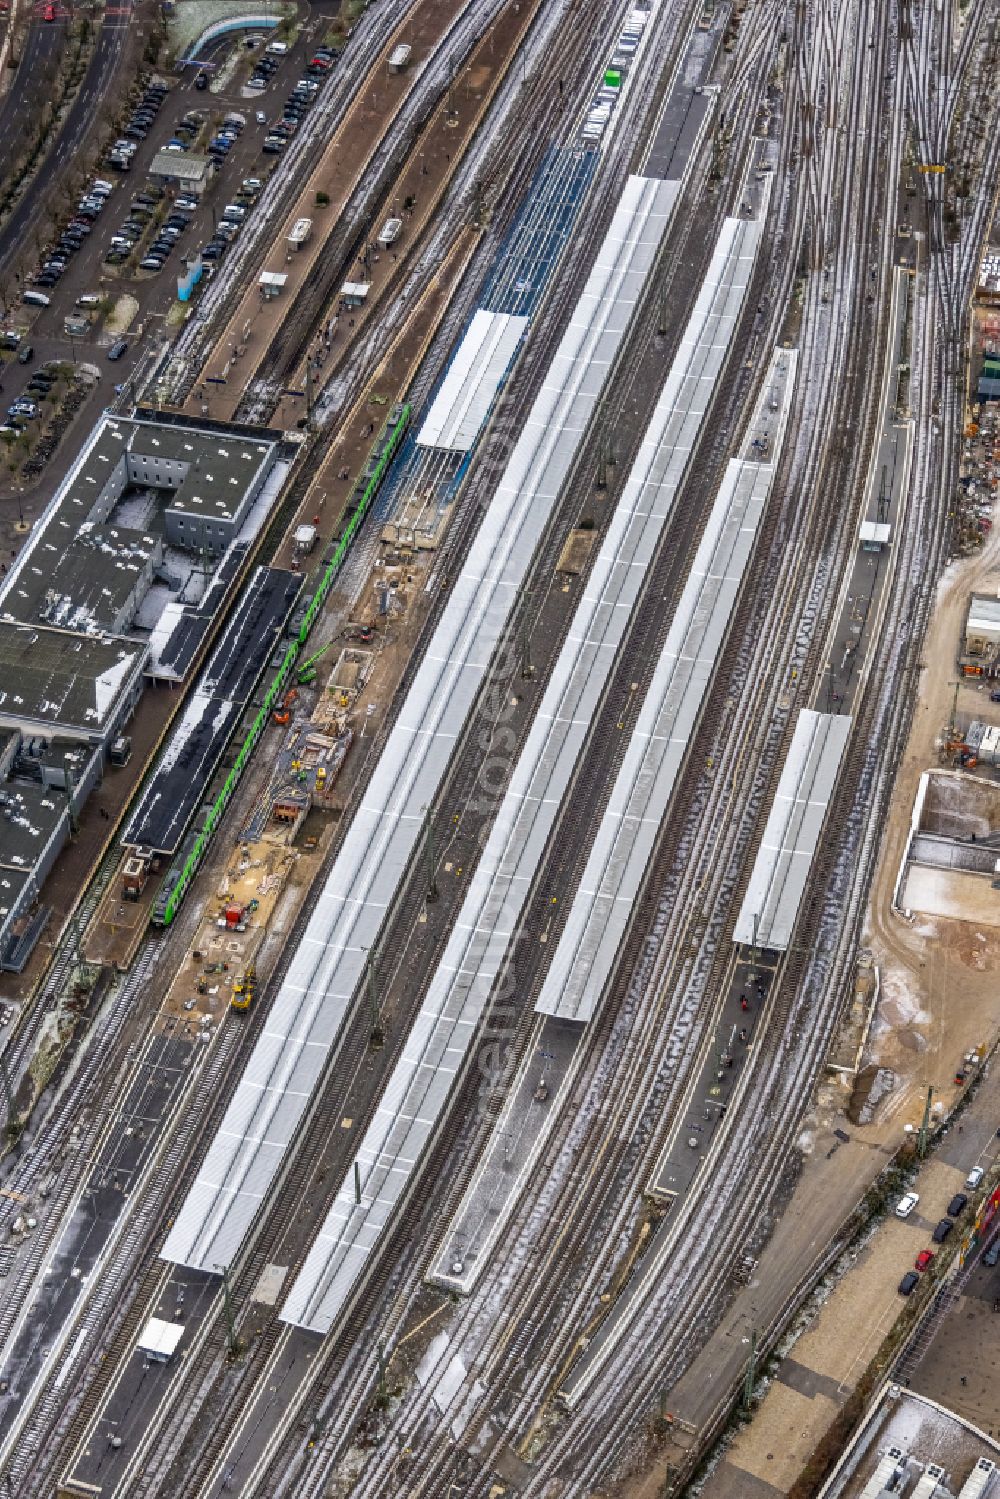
0, 411, 286, 681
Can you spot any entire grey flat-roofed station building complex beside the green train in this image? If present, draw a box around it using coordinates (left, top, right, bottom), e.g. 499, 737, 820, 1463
0, 411, 288, 968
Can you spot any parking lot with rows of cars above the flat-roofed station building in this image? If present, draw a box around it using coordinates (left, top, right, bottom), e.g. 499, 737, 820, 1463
0, 15, 336, 520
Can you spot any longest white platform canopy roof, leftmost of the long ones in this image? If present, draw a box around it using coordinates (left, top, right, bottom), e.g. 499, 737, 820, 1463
162, 178, 678, 1277
